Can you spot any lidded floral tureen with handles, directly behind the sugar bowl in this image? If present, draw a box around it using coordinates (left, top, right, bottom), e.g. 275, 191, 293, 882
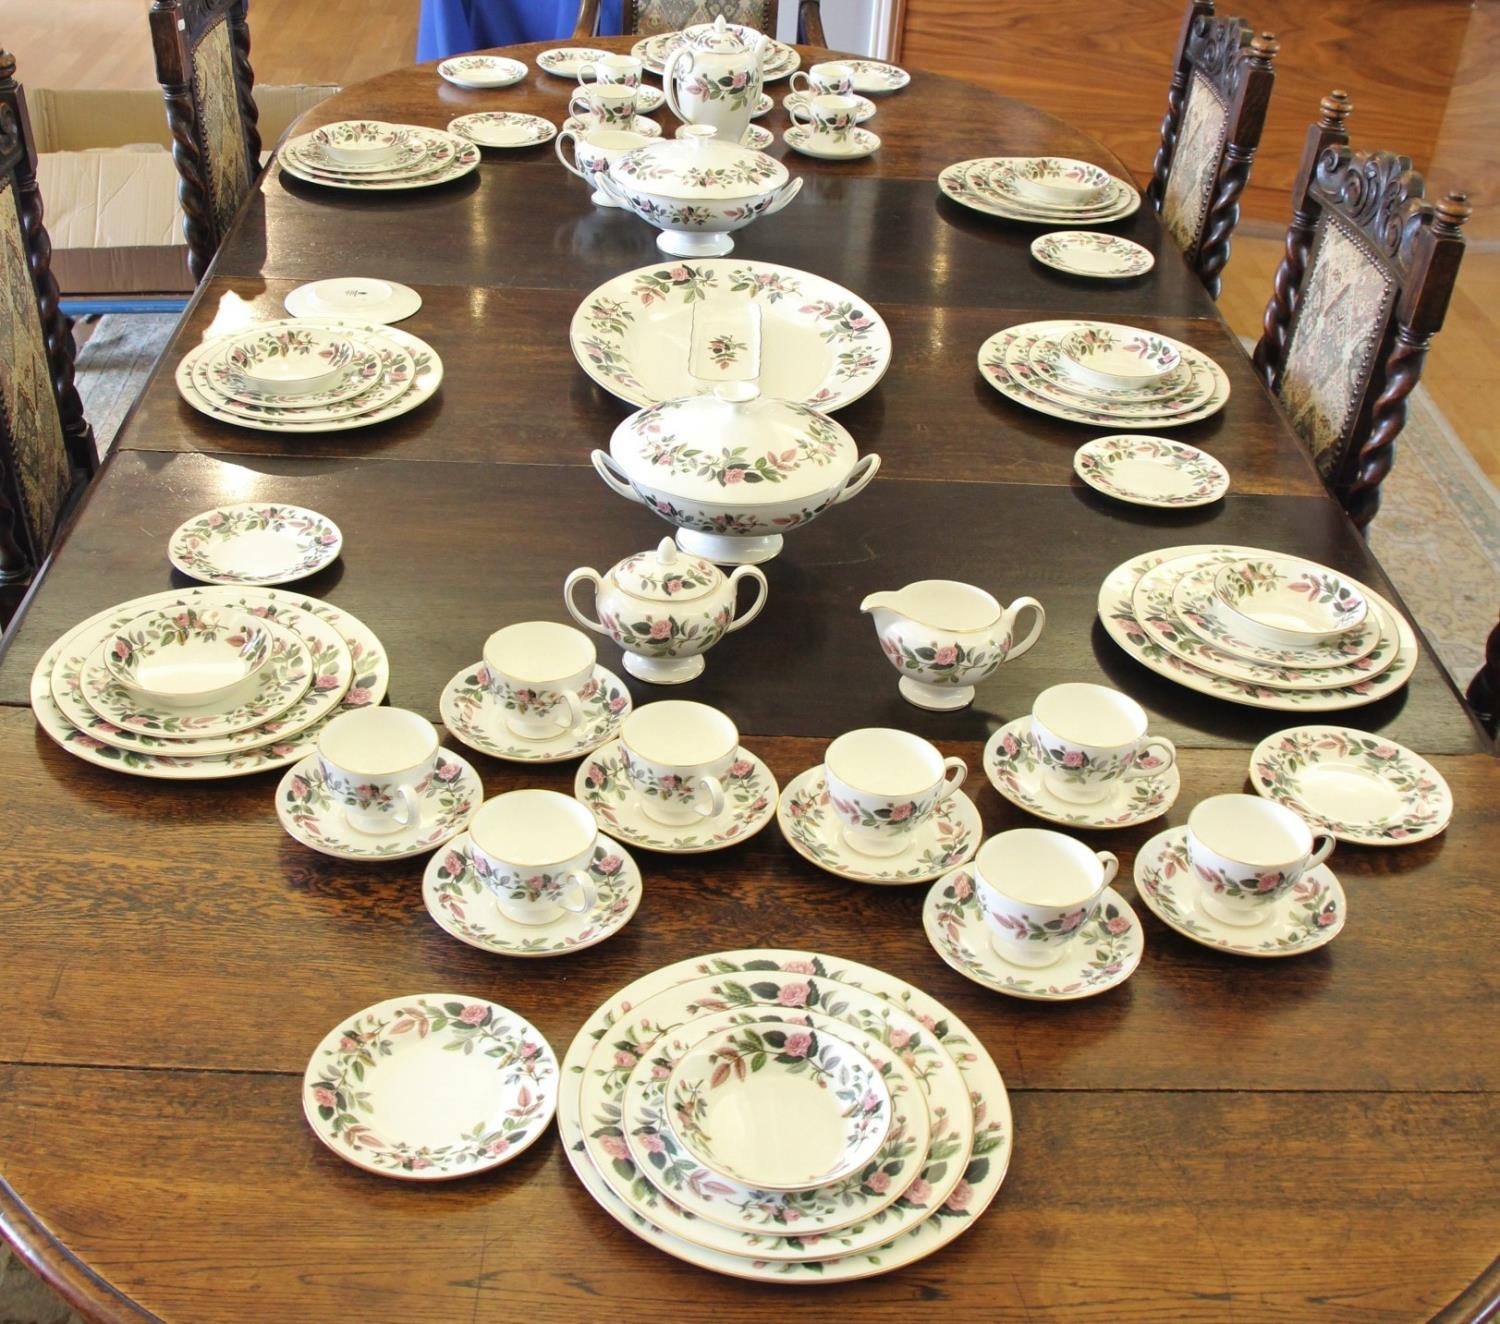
593, 382, 881, 565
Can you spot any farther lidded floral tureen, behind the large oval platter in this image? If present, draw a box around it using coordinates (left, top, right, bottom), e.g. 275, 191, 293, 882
599, 124, 803, 258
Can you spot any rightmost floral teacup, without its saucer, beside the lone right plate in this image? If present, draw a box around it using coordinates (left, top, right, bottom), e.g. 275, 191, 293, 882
1188, 795, 1334, 925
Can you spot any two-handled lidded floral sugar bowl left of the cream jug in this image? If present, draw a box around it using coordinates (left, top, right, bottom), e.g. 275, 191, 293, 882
563, 537, 767, 685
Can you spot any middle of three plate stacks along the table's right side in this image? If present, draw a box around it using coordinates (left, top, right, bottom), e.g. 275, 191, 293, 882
980, 321, 1229, 432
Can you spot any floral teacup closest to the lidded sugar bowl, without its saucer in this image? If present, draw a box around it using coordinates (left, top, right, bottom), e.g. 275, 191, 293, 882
485, 621, 594, 741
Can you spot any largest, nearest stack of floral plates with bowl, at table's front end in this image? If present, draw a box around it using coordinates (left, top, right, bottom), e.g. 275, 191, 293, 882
558, 949, 1013, 1284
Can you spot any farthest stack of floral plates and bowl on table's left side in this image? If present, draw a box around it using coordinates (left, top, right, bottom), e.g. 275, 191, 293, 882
278, 120, 480, 190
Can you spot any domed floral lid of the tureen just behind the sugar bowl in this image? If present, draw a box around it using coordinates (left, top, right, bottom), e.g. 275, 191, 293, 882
609, 382, 860, 505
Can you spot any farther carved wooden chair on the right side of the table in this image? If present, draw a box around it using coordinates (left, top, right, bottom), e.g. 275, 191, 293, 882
1146, 0, 1281, 298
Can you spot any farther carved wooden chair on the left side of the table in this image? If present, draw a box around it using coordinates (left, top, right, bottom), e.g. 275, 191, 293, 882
152, 0, 261, 280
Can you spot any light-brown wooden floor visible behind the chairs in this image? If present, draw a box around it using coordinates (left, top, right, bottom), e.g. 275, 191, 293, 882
0, 0, 1500, 484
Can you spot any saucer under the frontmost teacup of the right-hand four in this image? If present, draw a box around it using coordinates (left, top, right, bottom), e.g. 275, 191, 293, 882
923, 868, 1146, 1002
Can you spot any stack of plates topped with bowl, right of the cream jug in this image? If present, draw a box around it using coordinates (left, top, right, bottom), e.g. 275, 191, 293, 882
1100, 544, 1418, 712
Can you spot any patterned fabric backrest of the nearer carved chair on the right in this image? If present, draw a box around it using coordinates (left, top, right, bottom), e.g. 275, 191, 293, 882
1277, 217, 1395, 478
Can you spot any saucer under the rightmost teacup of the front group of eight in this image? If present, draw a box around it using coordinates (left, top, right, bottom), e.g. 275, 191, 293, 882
1136, 828, 1347, 957
